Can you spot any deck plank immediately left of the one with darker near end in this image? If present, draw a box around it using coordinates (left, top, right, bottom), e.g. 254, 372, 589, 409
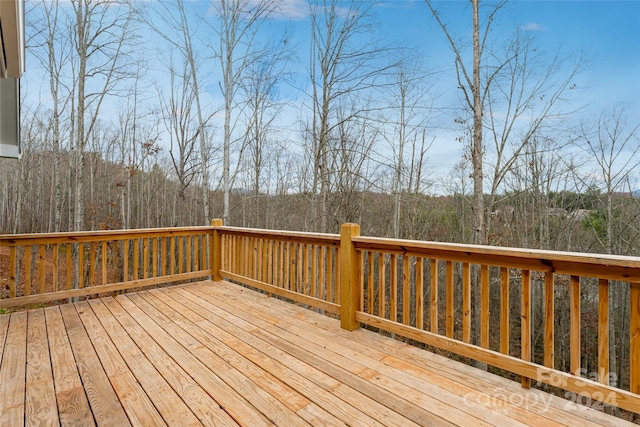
25, 309, 59, 426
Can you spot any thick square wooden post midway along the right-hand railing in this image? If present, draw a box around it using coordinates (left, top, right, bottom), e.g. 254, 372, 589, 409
340, 224, 361, 331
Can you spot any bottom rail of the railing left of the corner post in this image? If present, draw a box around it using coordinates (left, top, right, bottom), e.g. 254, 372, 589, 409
0, 270, 213, 308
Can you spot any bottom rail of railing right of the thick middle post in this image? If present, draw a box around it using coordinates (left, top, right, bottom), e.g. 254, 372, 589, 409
356, 311, 640, 413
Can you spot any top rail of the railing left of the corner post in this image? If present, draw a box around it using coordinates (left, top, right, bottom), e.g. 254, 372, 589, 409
0, 226, 214, 246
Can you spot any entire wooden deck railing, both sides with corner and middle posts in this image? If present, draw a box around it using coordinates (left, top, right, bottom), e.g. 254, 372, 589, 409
0, 220, 640, 413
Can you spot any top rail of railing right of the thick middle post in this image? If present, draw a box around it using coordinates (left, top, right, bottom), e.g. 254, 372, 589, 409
352, 236, 640, 282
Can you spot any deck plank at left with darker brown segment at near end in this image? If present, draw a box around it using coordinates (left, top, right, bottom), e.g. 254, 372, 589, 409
44, 307, 95, 426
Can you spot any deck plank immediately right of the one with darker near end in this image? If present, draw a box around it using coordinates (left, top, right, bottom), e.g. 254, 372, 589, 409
60, 305, 130, 426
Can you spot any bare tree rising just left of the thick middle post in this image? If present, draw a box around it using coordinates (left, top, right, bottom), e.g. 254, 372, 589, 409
307, 0, 392, 232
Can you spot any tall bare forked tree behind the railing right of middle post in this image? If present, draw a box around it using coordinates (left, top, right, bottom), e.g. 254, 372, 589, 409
426, 0, 583, 244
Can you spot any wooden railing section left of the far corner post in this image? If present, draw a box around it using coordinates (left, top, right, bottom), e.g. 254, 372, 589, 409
0, 227, 213, 308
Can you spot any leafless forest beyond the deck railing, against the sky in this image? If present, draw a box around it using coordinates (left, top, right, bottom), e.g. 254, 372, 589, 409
0, 0, 640, 412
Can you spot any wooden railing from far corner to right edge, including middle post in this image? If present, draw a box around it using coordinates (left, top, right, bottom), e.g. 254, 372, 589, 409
214, 224, 640, 413
